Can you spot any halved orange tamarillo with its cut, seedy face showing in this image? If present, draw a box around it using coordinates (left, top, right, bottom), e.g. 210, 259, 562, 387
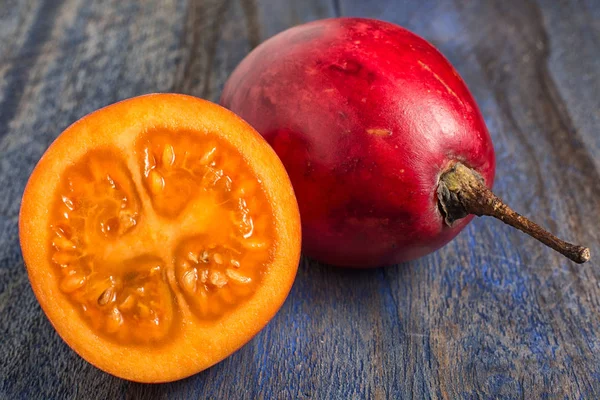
19, 94, 301, 382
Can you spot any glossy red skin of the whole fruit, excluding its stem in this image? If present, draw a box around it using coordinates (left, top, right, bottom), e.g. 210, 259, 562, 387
221, 18, 495, 267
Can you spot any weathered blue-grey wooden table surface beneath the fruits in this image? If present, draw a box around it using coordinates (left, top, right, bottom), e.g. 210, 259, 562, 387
0, 0, 600, 399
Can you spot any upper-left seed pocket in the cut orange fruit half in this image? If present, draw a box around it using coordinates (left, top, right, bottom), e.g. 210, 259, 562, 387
51, 152, 140, 293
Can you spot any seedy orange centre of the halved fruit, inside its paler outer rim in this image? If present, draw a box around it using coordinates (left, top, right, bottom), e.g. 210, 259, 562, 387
49, 130, 274, 344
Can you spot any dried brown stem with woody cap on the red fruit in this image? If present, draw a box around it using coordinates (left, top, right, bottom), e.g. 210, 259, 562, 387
438, 162, 590, 264
